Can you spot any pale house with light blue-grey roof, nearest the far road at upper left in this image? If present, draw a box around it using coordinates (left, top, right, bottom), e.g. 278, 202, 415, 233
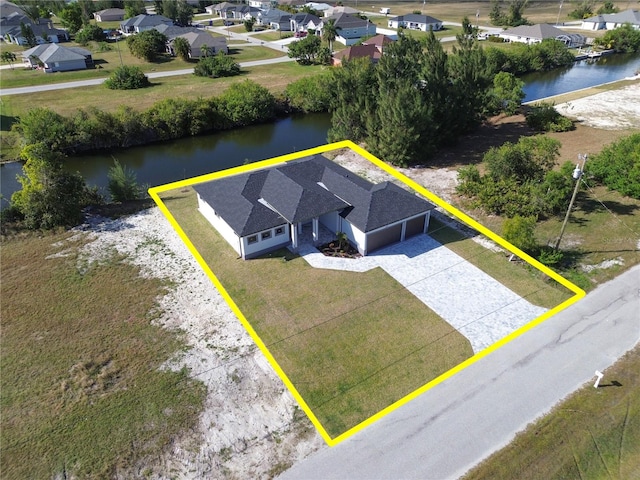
22, 43, 93, 73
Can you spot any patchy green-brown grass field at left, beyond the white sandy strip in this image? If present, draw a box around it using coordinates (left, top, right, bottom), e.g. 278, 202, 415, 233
0, 233, 205, 479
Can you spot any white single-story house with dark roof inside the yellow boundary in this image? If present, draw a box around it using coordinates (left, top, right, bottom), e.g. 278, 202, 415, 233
194, 155, 434, 259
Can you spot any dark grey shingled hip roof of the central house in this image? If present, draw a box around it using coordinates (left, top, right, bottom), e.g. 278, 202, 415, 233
194, 155, 433, 236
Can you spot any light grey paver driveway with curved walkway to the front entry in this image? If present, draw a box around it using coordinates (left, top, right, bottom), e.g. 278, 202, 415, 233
298, 235, 547, 353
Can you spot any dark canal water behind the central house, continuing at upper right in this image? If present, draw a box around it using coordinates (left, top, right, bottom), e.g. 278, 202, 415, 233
0, 53, 640, 202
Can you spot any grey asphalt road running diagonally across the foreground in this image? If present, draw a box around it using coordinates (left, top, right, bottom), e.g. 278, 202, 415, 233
278, 265, 640, 480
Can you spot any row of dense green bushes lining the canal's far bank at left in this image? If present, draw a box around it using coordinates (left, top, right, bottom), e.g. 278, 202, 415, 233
13, 80, 280, 155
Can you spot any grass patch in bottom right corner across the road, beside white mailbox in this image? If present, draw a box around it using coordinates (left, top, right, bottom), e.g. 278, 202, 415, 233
464, 347, 640, 480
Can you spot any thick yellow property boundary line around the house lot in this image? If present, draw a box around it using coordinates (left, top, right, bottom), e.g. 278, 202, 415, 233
149, 140, 585, 446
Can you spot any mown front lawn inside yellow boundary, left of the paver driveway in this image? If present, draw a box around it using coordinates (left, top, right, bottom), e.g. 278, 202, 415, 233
163, 189, 473, 437
